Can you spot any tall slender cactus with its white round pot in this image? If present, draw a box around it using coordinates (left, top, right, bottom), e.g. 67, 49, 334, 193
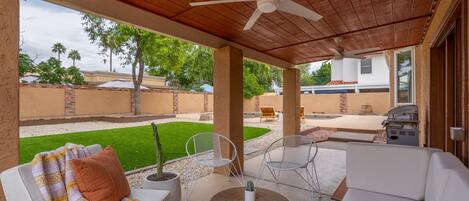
143, 123, 181, 201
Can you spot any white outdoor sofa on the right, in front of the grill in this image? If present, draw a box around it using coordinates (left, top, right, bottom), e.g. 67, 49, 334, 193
343, 143, 469, 201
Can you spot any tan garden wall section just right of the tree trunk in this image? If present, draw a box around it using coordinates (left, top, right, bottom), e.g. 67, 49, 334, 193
141, 92, 173, 114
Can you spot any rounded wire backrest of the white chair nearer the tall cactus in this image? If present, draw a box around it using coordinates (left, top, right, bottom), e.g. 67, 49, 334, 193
186, 132, 237, 166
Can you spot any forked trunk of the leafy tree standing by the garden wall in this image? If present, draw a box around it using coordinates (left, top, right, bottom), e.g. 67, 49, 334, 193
132, 34, 145, 115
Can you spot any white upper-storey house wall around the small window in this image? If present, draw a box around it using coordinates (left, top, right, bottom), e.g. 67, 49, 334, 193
357, 54, 389, 85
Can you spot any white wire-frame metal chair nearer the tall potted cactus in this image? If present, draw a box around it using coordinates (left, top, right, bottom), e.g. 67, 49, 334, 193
186, 132, 244, 200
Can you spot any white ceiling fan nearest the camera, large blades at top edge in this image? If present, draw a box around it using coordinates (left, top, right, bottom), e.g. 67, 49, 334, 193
190, 0, 322, 31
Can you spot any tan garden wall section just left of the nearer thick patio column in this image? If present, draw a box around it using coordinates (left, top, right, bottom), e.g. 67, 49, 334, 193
178, 93, 204, 113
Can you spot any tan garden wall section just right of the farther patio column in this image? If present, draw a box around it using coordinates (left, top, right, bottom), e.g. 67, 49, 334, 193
301, 94, 340, 114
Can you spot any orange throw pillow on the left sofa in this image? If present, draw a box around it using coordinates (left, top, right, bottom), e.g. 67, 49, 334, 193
71, 146, 130, 201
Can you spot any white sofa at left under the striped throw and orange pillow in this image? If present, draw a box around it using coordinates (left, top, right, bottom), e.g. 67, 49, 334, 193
1, 144, 169, 201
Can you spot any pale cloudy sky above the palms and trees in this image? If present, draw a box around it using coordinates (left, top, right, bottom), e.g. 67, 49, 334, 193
20, 0, 321, 73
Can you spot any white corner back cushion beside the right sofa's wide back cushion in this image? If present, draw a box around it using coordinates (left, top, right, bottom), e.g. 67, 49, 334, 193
425, 152, 466, 201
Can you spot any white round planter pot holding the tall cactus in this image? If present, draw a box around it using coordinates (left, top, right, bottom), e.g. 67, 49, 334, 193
143, 172, 181, 201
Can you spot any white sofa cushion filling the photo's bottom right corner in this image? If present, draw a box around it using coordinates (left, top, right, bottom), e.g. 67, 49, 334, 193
441, 169, 469, 201
